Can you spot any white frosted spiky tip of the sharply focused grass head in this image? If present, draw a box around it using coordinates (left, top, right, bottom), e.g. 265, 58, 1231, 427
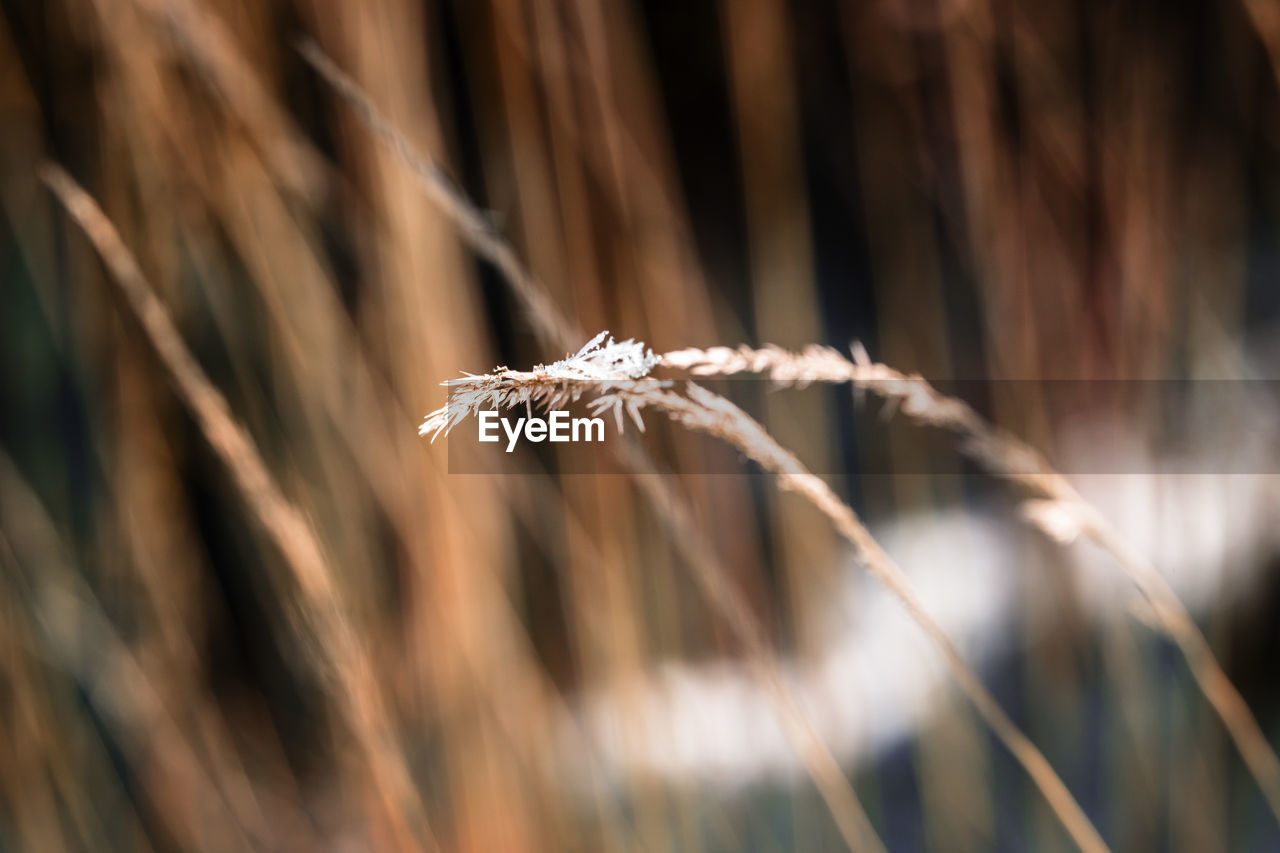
417, 332, 668, 442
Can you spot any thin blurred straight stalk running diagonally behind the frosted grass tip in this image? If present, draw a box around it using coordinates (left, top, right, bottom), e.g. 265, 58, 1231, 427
307, 40, 883, 850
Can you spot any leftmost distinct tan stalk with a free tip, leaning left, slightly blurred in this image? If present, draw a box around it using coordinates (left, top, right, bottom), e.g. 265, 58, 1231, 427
41, 164, 436, 849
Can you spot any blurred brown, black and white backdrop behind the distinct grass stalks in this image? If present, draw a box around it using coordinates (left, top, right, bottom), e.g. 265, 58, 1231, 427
0, 0, 1280, 850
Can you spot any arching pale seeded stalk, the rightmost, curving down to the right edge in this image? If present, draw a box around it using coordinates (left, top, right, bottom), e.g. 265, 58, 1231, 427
662, 346, 1280, 818
